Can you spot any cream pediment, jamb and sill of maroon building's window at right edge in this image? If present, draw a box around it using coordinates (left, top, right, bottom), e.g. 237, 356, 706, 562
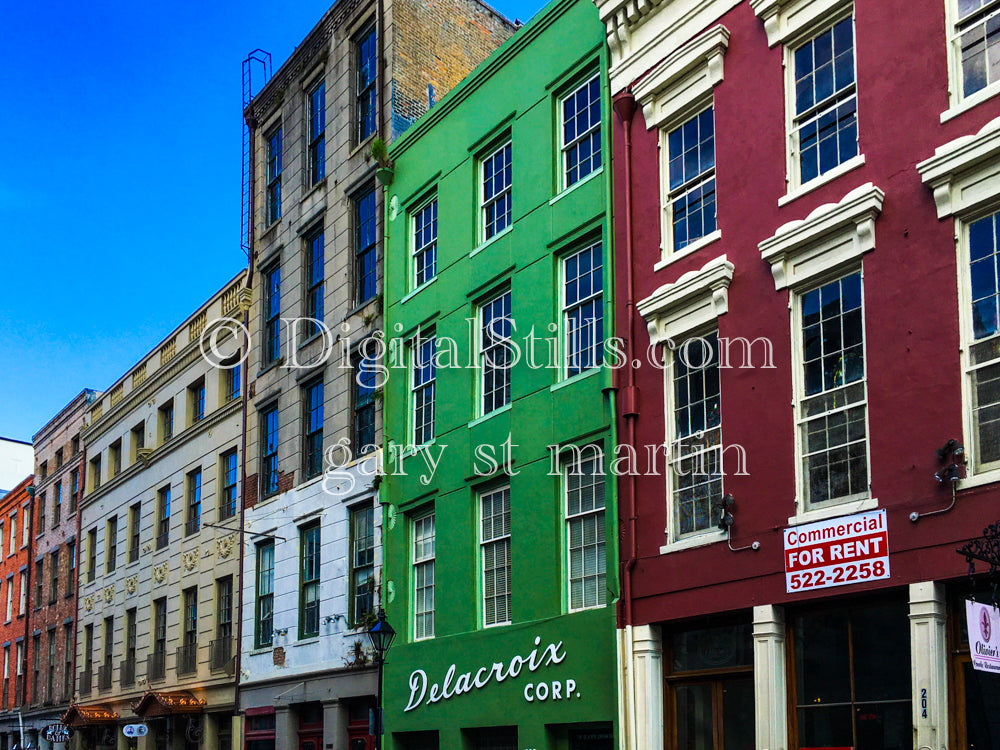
917, 117, 1000, 487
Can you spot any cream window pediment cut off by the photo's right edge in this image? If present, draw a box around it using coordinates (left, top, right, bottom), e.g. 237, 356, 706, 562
917, 117, 1000, 219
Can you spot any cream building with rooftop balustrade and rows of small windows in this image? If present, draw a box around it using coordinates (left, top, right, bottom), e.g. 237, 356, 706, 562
66, 273, 245, 750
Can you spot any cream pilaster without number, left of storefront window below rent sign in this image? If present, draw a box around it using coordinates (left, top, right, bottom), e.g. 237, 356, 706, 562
753, 604, 788, 750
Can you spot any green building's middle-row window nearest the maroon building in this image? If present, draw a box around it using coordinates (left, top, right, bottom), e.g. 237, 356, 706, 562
563, 242, 604, 376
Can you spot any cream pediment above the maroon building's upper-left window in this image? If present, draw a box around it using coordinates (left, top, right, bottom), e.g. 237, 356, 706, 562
634, 24, 729, 128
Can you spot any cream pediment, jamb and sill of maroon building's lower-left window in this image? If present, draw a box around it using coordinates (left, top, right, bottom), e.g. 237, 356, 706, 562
637, 255, 735, 554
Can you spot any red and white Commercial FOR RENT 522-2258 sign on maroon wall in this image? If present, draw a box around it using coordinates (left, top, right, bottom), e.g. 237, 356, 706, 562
784, 510, 889, 593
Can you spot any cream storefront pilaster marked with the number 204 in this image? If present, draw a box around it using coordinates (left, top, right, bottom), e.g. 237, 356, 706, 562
910, 581, 948, 750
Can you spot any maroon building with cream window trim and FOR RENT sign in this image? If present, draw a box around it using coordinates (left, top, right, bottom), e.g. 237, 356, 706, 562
597, 0, 1000, 750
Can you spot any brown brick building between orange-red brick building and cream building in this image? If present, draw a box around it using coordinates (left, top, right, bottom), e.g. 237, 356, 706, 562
23, 389, 99, 747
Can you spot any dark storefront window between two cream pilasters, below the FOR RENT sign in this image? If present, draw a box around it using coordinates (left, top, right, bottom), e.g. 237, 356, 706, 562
792, 602, 913, 750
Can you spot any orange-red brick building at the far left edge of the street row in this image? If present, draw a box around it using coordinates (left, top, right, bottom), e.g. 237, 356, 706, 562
0, 476, 35, 750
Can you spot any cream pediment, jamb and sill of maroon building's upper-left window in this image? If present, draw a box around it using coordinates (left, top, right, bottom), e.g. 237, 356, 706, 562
635, 24, 729, 268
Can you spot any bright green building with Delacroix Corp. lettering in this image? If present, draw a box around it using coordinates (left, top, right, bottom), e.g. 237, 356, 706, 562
380, 0, 618, 750
